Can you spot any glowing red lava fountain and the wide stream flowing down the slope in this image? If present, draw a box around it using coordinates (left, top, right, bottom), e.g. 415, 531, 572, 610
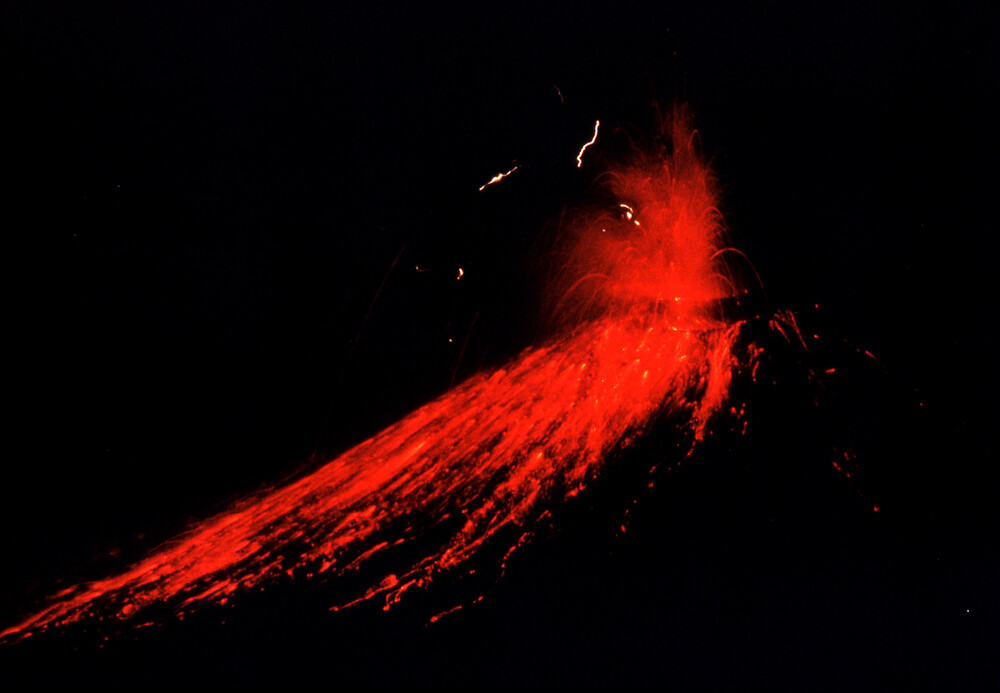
0, 105, 752, 638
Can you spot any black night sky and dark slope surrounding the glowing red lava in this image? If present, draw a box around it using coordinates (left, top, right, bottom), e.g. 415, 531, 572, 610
0, 2, 1000, 690
